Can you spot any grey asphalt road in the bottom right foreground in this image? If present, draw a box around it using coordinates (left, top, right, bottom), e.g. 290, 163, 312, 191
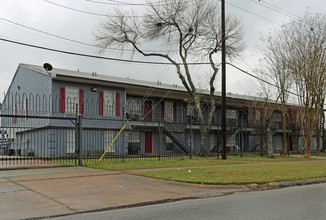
55, 184, 326, 220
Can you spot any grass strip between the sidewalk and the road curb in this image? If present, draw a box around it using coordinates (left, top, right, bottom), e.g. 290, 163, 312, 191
137, 161, 326, 184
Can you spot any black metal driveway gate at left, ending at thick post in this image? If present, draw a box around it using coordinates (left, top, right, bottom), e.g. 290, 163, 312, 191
0, 114, 80, 169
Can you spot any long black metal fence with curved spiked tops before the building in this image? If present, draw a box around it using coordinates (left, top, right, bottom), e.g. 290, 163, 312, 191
0, 91, 308, 167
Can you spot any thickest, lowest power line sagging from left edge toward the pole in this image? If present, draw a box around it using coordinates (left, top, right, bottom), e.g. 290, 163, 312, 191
0, 38, 211, 65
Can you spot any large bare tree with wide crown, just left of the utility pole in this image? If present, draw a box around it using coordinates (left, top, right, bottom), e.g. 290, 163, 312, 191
95, 0, 243, 156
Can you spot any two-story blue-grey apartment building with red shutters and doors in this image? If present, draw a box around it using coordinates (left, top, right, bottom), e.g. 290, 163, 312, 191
1, 64, 306, 157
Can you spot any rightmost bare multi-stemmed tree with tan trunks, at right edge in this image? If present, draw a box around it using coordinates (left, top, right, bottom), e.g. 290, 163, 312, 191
264, 13, 326, 158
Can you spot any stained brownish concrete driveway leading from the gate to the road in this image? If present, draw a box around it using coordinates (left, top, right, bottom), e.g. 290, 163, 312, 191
0, 167, 249, 219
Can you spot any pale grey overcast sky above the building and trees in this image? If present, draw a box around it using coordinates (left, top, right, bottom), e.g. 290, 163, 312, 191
0, 0, 326, 102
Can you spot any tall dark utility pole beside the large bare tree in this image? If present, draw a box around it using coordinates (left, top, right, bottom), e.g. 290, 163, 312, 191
221, 0, 226, 160
